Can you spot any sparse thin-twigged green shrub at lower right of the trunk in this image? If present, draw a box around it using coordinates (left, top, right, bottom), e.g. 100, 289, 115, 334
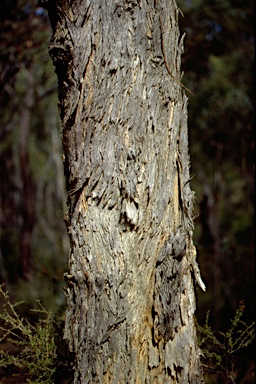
197, 301, 255, 383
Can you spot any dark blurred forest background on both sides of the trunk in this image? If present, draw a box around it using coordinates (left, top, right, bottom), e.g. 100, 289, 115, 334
0, 0, 255, 382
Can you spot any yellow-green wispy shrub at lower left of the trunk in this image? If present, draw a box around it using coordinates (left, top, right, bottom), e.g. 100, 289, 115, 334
0, 285, 57, 384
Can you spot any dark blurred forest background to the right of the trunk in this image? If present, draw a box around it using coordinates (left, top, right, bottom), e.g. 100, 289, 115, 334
177, 0, 255, 348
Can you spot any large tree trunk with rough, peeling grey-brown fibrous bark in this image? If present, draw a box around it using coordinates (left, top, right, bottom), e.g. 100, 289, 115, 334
49, 0, 204, 384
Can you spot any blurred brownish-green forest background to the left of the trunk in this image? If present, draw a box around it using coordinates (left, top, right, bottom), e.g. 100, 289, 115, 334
0, 0, 69, 286
